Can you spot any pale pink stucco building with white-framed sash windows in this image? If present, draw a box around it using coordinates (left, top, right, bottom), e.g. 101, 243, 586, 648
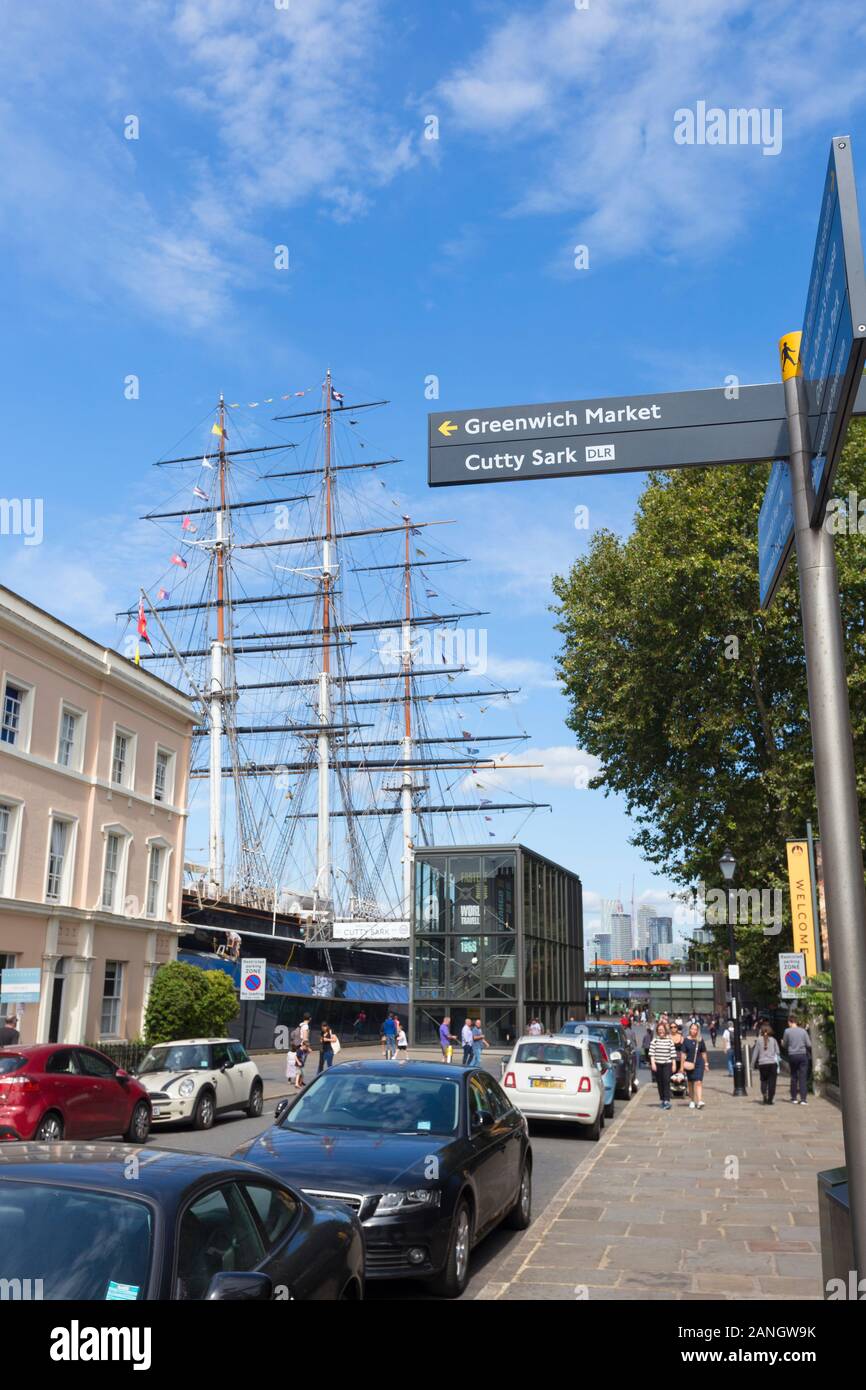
0, 587, 195, 1043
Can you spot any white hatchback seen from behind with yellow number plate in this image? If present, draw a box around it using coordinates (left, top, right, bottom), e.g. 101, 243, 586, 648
502, 1033, 605, 1138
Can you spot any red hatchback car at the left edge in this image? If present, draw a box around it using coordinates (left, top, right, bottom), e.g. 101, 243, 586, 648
0, 1043, 150, 1144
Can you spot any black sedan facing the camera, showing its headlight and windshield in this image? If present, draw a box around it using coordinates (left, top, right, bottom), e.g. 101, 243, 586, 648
235, 1061, 532, 1298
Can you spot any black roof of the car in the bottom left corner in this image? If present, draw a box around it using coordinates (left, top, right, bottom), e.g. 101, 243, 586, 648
0, 1141, 280, 1197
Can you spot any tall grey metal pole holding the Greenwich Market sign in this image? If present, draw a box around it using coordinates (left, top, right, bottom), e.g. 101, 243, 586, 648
784, 344, 866, 1272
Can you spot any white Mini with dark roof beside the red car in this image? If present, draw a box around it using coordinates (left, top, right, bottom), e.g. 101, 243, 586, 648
136, 1038, 264, 1129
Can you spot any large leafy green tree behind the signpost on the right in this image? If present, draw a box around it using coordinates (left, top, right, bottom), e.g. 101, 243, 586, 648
553, 421, 866, 998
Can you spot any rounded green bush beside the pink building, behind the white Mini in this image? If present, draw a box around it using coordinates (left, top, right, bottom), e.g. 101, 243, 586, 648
145, 960, 239, 1044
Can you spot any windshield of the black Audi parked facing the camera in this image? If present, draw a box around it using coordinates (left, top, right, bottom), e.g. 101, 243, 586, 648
279, 1068, 460, 1136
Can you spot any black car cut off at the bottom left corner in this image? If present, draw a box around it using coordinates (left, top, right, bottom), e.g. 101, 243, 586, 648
0, 1144, 364, 1301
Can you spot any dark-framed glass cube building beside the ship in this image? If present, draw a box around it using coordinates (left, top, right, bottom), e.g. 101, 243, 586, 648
410, 845, 587, 1056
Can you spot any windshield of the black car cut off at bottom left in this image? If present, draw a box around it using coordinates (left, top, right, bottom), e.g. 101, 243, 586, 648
0, 1179, 153, 1302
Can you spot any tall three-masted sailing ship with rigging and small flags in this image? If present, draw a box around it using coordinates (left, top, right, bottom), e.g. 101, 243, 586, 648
124, 373, 546, 1034
